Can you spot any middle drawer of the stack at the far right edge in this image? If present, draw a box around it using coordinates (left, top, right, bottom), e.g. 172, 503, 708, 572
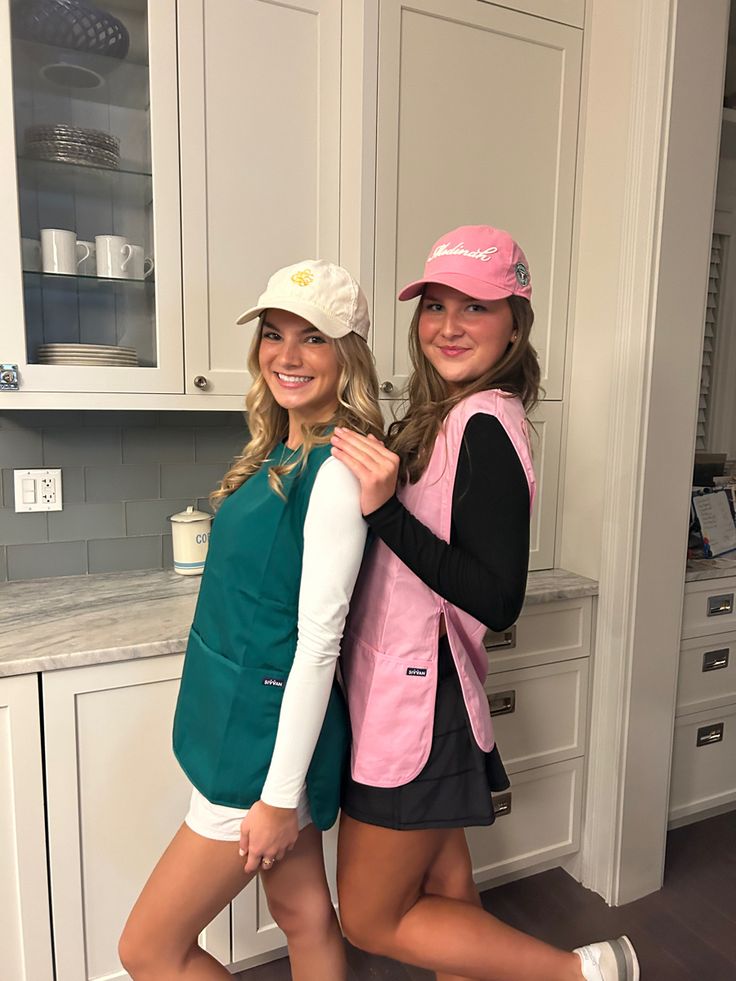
677, 632, 736, 715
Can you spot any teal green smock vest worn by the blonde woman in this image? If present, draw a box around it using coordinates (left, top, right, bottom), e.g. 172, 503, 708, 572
174, 445, 350, 830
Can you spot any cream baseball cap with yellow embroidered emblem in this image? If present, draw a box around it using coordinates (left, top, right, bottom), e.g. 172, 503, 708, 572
237, 259, 371, 340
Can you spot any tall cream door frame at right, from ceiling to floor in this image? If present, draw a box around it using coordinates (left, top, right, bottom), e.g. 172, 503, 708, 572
561, 0, 728, 905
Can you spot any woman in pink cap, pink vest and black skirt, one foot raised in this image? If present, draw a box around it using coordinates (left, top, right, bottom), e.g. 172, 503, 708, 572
332, 225, 639, 981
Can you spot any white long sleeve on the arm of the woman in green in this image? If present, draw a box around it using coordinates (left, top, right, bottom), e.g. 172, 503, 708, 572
261, 457, 368, 807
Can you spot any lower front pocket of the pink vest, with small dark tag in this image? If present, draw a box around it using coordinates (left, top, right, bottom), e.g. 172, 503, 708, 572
347, 638, 437, 787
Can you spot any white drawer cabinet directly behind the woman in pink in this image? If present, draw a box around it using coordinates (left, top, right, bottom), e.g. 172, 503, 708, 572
467, 596, 594, 885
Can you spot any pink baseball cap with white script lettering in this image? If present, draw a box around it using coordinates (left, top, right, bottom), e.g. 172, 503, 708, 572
399, 225, 532, 300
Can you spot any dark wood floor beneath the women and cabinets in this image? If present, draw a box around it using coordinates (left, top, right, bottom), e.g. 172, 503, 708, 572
240, 811, 736, 981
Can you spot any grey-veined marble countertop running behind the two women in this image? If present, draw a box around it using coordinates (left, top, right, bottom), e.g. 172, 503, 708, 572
0, 569, 598, 677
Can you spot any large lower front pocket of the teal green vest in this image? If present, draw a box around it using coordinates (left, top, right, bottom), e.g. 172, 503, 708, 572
174, 629, 286, 807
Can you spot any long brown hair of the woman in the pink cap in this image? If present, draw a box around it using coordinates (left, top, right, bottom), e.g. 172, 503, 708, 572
386, 296, 540, 484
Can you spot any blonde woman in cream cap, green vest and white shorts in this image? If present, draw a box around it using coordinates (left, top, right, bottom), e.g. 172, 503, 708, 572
120, 260, 382, 981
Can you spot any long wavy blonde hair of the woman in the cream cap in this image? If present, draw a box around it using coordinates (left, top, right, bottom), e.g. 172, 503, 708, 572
210, 311, 383, 508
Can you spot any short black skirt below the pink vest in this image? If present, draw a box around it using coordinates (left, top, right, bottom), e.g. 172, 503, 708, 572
342, 637, 510, 831
